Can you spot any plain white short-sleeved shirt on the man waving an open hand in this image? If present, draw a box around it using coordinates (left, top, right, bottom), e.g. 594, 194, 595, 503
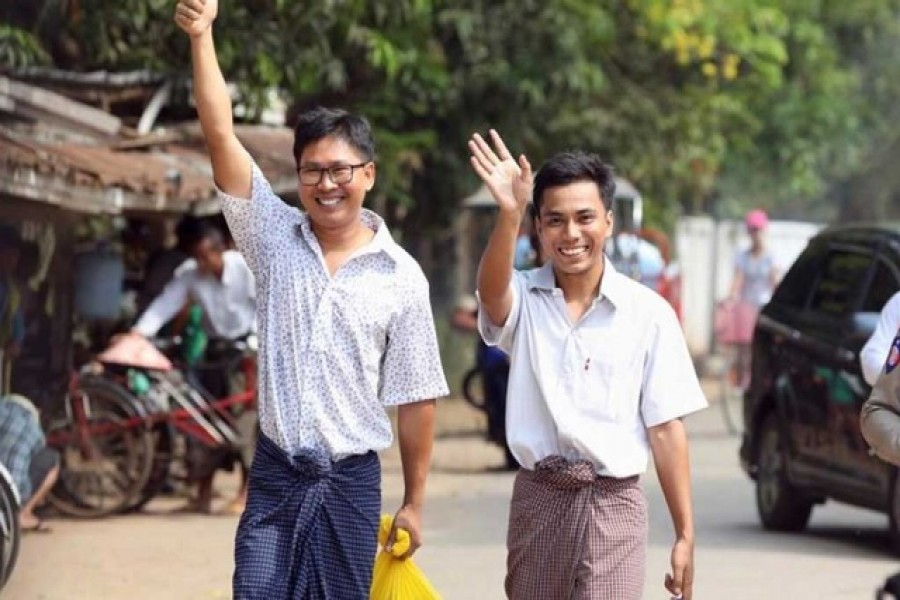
479, 259, 707, 477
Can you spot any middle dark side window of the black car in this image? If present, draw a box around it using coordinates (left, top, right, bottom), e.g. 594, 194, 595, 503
809, 250, 872, 317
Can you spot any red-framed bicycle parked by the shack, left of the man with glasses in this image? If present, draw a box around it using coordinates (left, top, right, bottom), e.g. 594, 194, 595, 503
46, 338, 256, 518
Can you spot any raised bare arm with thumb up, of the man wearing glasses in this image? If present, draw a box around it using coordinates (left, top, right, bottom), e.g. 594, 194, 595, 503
175, 0, 252, 198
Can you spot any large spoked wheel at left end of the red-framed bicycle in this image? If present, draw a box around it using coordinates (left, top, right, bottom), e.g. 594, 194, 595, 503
47, 377, 154, 518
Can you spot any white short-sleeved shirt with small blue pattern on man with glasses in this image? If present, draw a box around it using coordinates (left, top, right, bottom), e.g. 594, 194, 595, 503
219, 164, 448, 458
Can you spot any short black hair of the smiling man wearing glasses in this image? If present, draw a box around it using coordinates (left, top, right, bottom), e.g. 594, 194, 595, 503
294, 107, 375, 166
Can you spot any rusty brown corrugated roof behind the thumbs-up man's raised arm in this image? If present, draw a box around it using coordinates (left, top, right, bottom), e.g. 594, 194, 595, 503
0, 125, 296, 212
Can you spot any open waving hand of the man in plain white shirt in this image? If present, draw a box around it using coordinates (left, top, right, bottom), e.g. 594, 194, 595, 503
469, 129, 532, 211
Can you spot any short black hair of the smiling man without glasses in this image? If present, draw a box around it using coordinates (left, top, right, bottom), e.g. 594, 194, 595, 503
531, 151, 616, 217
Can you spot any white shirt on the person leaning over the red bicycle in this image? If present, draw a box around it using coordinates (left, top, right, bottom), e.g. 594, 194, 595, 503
134, 250, 256, 340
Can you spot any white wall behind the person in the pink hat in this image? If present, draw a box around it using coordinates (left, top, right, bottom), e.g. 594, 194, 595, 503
675, 217, 822, 357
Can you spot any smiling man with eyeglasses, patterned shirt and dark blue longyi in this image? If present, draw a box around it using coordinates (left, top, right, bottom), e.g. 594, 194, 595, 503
175, 0, 448, 600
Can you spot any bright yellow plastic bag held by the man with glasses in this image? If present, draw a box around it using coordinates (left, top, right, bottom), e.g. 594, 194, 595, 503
369, 515, 441, 600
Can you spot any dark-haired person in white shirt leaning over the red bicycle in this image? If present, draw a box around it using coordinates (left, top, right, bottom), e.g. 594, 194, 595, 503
126, 222, 256, 514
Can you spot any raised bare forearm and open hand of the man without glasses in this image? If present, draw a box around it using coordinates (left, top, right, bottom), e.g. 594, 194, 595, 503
469, 129, 532, 325
